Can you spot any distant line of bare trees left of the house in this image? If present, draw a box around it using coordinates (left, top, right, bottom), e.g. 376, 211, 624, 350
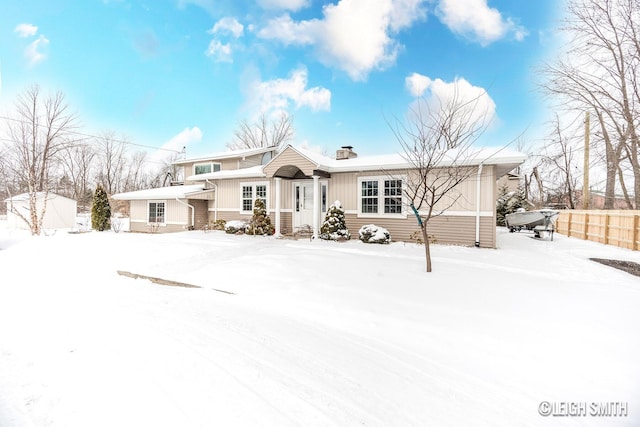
0, 85, 178, 220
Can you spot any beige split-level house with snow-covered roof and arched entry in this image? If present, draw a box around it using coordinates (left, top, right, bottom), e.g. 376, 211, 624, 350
113, 144, 525, 247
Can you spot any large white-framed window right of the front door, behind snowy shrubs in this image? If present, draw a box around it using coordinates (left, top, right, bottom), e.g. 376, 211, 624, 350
358, 177, 405, 216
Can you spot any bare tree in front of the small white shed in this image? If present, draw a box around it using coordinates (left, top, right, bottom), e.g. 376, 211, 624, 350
5, 86, 76, 235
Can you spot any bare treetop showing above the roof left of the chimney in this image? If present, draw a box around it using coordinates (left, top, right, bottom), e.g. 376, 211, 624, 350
227, 112, 293, 150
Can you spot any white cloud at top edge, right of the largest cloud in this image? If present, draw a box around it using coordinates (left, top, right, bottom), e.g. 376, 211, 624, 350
436, 0, 528, 46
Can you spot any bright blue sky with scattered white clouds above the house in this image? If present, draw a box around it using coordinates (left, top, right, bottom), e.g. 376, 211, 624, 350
0, 0, 560, 157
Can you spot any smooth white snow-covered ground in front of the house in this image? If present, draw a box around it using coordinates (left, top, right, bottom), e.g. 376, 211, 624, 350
0, 222, 640, 427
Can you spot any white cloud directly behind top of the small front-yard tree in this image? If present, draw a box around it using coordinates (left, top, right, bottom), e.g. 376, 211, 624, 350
411, 73, 497, 129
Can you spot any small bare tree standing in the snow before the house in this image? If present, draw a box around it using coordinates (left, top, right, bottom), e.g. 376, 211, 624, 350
391, 93, 488, 272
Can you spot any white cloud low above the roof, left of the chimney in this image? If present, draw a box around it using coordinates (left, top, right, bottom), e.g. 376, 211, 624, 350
250, 68, 331, 116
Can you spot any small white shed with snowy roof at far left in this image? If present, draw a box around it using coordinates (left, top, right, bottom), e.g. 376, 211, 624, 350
5, 192, 77, 230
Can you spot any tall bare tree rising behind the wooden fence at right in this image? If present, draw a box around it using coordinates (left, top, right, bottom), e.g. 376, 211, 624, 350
542, 0, 640, 209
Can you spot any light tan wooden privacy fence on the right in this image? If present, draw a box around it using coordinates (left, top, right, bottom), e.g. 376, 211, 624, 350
556, 210, 640, 251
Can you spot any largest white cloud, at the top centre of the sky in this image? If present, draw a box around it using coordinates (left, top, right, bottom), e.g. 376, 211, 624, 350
258, 0, 426, 80
